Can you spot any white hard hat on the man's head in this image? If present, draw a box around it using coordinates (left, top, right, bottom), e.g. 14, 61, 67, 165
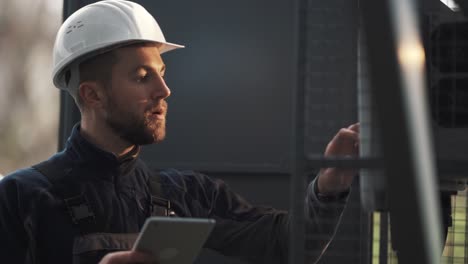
53, 0, 184, 89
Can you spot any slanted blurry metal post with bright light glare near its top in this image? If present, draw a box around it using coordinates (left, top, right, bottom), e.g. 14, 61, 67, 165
361, 0, 442, 264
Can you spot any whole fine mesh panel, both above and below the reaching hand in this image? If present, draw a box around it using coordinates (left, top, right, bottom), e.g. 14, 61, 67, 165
303, 0, 370, 263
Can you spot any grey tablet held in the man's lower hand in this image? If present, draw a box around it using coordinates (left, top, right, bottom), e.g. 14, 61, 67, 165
133, 216, 215, 264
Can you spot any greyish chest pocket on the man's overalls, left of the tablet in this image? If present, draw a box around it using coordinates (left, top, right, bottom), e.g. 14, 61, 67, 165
73, 233, 138, 264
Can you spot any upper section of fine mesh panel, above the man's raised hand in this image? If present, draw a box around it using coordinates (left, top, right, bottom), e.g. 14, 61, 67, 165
304, 0, 358, 159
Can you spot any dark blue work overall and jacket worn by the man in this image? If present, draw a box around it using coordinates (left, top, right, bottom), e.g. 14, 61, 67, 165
0, 125, 342, 264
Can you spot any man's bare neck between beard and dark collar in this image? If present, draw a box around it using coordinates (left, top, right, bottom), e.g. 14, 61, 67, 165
80, 119, 135, 158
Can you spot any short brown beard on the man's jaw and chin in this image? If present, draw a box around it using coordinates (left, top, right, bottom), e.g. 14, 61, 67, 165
105, 96, 167, 145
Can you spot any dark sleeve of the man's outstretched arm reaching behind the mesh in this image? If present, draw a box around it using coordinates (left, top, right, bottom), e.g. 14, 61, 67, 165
175, 170, 344, 264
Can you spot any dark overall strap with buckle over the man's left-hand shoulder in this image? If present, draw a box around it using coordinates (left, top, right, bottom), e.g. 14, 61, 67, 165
32, 159, 96, 233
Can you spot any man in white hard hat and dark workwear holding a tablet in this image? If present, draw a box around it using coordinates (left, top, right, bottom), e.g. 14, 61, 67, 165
0, 0, 358, 263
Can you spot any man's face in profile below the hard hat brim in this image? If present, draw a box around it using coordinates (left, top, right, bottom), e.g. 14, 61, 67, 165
103, 46, 170, 145
